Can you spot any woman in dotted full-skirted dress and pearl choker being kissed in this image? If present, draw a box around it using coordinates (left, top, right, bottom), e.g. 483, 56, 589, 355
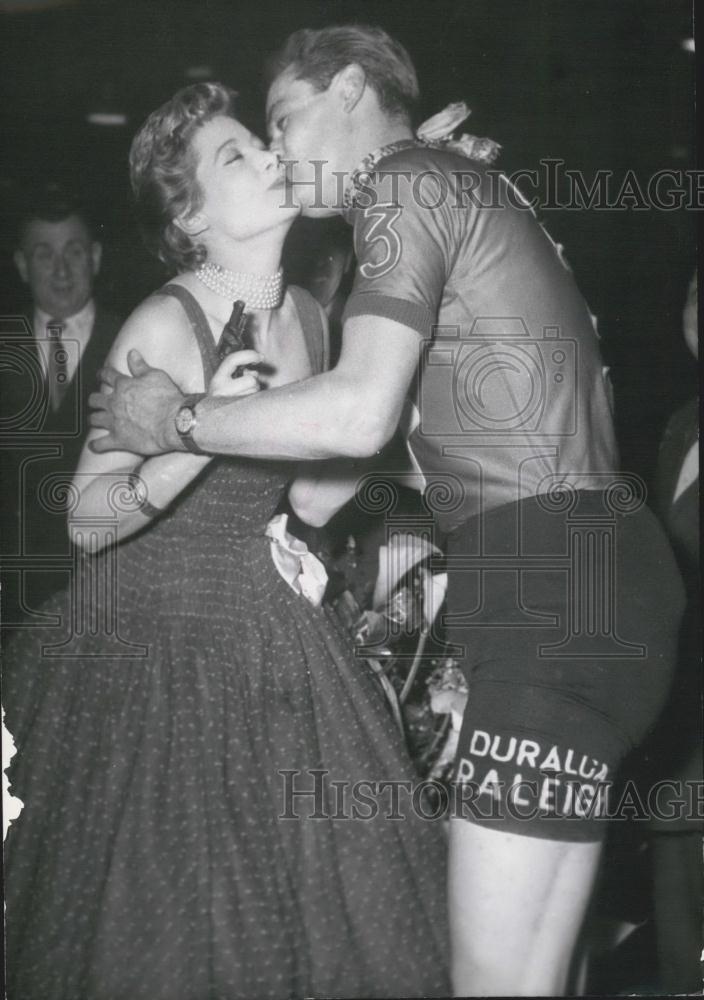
3, 84, 449, 1000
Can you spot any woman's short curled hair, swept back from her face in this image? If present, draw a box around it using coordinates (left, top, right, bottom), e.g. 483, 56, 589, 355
130, 83, 237, 271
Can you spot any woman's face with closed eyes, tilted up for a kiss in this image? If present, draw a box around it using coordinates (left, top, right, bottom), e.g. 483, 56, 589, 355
186, 116, 299, 243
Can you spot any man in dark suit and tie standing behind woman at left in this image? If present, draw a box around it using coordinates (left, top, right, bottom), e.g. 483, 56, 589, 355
0, 185, 120, 628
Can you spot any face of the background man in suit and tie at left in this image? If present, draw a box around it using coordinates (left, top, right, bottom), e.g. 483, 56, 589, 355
15, 215, 101, 319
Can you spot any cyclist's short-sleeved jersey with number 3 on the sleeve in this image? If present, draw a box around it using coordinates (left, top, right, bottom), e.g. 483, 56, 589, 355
343, 140, 618, 530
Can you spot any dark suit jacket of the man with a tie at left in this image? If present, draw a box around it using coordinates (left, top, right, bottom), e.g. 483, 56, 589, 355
0, 303, 121, 621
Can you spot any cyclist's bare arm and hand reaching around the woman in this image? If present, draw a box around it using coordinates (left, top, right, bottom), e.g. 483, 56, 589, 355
91, 315, 421, 459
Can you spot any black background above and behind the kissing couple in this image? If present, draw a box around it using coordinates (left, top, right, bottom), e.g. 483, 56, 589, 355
0, 0, 696, 488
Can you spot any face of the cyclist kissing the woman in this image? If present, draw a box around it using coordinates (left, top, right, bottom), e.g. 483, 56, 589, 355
266, 70, 350, 216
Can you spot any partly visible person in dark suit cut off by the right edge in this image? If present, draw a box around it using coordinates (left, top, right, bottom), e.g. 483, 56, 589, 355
644, 273, 704, 994
